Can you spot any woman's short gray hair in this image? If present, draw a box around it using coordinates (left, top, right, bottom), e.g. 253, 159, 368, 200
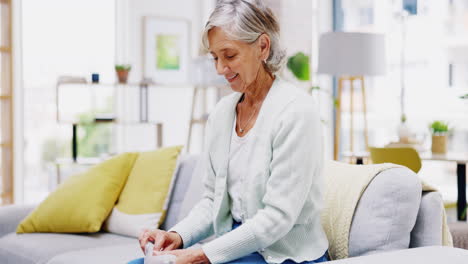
202, 0, 286, 73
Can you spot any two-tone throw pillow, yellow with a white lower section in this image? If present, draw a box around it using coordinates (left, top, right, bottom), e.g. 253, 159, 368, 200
104, 146, 182, 237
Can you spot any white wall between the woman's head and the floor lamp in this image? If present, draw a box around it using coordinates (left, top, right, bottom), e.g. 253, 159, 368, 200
276, 0, 333, 158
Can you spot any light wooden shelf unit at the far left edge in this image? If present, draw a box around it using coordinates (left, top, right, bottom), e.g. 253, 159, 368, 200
0, 0, 15, 205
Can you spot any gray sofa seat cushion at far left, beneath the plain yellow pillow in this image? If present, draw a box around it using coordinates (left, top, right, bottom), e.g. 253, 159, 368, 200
0, 233, 133, 264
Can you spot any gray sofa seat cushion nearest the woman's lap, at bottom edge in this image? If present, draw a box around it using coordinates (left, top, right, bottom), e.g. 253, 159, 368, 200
47, 243, 143, 264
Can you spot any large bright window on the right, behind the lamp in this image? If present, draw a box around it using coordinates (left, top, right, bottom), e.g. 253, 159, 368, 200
341, 0, 468, 152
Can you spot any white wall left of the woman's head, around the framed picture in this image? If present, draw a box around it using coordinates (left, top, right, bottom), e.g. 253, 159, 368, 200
116, 0, 214, 151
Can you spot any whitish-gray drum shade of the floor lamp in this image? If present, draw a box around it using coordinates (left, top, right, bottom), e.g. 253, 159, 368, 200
318, 32, 386, 76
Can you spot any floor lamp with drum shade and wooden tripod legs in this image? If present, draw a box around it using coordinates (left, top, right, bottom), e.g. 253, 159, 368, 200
318, 32, 386, 160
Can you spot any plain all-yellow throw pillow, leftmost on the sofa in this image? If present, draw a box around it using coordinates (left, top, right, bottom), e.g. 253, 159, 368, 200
16, 153, 138, 233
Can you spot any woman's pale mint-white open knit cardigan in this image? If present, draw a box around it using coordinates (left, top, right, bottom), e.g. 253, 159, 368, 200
171, 77, 328, 263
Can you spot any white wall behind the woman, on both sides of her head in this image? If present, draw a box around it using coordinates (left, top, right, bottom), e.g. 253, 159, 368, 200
116, 0, 333, 157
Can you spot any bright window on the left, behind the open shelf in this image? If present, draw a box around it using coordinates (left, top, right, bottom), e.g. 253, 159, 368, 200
22, 0, 115, 203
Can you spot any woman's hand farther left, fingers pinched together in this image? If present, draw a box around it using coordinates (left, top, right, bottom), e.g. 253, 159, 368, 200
138, 229, 182, 255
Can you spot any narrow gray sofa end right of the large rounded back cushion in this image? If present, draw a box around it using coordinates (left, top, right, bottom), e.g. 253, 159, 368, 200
410, 192, 444, 248
